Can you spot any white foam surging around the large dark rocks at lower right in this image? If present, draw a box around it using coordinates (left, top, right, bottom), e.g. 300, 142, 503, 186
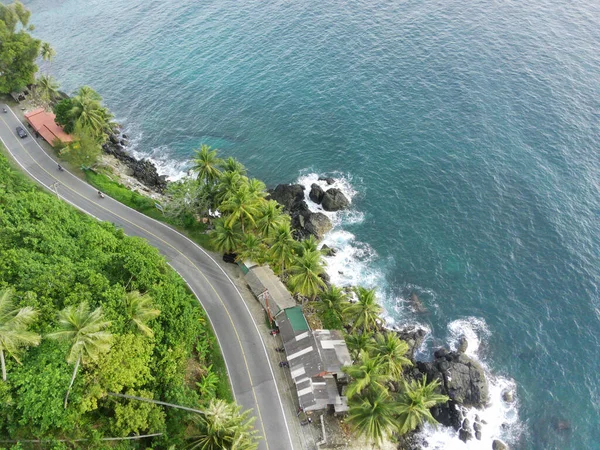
420, 317, 523, 450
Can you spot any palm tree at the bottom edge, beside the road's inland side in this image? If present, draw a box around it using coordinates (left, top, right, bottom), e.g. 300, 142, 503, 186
187, 399, 258, 450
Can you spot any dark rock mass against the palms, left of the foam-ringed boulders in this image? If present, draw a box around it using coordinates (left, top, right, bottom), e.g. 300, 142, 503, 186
269, 184, 333, 240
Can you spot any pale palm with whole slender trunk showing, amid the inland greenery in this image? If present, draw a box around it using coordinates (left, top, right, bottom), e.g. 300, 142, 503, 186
46, 302, 112, 408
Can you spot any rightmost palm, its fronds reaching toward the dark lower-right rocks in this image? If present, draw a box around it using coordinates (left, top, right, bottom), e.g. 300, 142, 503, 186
398, 377, 449, 434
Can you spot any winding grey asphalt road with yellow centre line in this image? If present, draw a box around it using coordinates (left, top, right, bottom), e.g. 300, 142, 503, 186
0, 105, 294, 450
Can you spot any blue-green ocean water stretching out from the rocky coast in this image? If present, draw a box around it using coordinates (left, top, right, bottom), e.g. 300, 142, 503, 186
24, 0, 600, 449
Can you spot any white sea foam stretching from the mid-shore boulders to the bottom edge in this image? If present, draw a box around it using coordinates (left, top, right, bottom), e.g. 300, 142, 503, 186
298, 172, 523, 450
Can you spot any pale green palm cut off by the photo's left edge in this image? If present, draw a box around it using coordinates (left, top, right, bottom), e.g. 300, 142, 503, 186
0, 289, 41, 381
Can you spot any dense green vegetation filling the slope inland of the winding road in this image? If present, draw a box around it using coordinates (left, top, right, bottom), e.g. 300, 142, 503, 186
0, 157, 254, 448
